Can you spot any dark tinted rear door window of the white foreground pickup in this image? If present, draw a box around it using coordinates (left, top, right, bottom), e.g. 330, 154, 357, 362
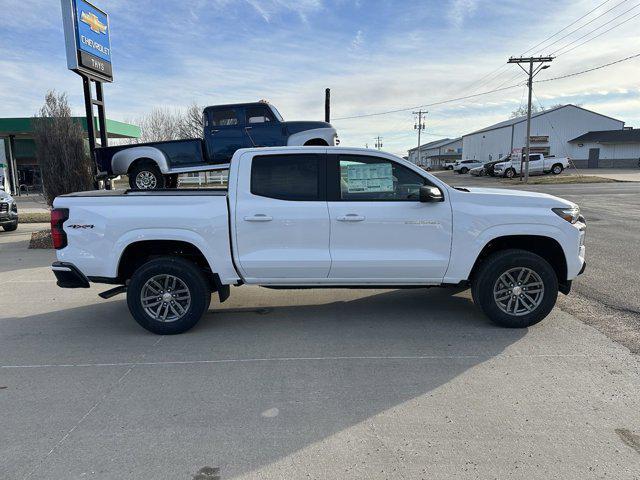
251, 154, 320, 201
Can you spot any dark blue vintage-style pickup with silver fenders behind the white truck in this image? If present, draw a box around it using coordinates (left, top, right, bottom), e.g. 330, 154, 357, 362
95, 102, 337, 189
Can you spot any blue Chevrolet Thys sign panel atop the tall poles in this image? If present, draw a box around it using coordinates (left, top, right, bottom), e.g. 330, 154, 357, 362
62, 0, 113, 82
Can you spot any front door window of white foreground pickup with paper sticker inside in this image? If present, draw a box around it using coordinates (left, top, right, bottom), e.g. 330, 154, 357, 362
338, 155, 426, 201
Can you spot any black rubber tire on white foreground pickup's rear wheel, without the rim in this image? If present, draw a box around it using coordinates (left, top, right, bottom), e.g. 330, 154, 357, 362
127, 257, 211, 335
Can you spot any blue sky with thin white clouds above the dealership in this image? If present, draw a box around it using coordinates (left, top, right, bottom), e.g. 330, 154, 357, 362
0, 0, 640, 154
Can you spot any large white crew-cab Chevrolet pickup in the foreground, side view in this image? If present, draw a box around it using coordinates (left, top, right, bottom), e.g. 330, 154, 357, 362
51, 147, 586, 334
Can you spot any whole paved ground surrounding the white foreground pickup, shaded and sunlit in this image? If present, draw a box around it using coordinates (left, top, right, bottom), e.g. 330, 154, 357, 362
0, 180, 640, 479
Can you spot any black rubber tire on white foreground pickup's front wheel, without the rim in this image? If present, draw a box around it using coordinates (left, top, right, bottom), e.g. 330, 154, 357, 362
471, 249, 558, 328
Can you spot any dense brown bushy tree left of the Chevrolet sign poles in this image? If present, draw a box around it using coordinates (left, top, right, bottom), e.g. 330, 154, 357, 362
33, 91, 93, 205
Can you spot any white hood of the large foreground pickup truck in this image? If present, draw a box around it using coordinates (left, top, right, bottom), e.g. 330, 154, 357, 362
458, 187, 576, 208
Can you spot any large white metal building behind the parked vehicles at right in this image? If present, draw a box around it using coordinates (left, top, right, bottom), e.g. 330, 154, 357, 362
462, 105, 624, 166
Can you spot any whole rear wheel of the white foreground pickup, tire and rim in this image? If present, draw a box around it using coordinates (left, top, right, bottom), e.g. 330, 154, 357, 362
127, 257, 211, 335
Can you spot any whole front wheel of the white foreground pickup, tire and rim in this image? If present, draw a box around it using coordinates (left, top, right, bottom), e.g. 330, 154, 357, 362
471, 249, 558, 328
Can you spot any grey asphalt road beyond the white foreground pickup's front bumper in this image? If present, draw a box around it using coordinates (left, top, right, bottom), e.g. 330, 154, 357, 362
438, 172, 640, 353
